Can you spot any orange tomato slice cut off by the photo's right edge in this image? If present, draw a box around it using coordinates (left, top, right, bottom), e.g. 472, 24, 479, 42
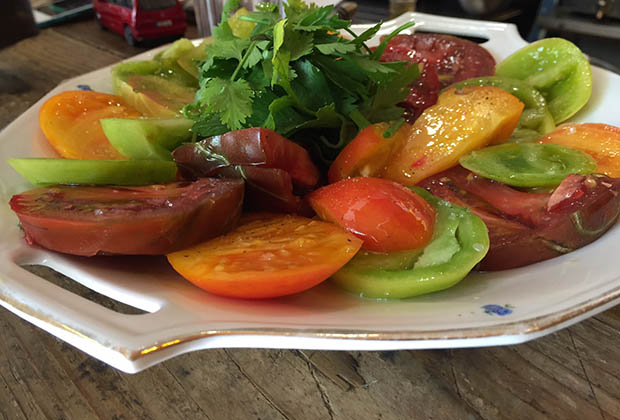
538, 123, 620, 178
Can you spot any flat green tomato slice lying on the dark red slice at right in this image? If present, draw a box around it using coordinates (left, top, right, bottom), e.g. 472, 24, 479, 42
459, 143, 596, 188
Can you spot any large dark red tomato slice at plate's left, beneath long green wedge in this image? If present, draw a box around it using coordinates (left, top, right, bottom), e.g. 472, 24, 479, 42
10, 178, 244, 256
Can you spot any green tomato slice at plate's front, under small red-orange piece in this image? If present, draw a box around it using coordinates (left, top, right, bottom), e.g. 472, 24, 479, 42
332, 187, 489, 299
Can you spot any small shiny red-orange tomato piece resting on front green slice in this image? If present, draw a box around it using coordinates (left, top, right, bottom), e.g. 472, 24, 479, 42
308, 177, 435, 252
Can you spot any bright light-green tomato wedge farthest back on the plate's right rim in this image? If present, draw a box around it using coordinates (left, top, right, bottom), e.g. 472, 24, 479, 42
495, 38, 592, 124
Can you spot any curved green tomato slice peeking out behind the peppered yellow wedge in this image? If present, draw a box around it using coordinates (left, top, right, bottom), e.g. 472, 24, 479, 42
450, 76, 555, 141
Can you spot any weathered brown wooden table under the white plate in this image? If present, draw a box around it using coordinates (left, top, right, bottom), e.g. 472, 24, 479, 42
0, 13, 620, 420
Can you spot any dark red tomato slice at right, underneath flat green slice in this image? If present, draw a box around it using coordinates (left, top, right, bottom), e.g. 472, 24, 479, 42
420, 167, 620, 270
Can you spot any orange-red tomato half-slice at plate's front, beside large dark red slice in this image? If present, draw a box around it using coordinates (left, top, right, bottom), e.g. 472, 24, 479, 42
168, 215, 362, 299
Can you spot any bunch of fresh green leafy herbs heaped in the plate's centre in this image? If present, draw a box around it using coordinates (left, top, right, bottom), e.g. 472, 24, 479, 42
184, 0, 419, 160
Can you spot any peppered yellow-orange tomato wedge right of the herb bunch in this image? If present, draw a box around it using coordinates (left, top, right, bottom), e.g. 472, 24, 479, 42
382, 86, 524, 185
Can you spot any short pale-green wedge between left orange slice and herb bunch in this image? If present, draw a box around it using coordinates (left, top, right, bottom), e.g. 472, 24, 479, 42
100, 118, 194, 160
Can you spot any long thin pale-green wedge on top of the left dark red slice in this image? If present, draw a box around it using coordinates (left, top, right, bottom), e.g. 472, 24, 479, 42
8, 158, 177, 186
